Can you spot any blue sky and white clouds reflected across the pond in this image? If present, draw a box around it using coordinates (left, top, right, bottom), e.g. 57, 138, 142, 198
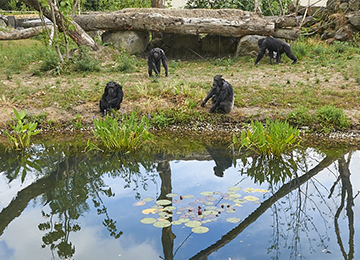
0, 149, 360, 260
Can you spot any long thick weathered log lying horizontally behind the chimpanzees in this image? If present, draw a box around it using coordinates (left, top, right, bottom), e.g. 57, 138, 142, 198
74, 8, 275, 37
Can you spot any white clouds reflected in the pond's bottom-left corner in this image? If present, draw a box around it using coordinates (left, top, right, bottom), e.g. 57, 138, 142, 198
0, 209, 161, 260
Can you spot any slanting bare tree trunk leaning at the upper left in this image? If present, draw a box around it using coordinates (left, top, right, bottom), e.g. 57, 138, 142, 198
21, 0, 101, 51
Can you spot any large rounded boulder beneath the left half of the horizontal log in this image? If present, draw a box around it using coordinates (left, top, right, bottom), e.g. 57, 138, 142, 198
101, 31, 149, 54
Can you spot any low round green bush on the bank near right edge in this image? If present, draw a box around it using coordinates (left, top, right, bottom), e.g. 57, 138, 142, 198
315, 105, 350, 132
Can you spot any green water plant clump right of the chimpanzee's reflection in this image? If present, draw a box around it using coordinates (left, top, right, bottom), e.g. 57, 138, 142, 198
233, 119, 300, 158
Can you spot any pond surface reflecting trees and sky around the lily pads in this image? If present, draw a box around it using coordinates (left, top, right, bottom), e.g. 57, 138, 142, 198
0, 142, 360, 260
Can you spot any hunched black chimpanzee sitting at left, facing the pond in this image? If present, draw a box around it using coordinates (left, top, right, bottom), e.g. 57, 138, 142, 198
100, 81, 124, 116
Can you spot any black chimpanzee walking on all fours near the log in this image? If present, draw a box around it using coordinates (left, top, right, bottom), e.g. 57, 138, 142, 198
255, 36, 297, 65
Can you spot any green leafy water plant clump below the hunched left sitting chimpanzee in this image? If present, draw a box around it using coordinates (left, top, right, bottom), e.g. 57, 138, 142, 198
88, 112, 153, 152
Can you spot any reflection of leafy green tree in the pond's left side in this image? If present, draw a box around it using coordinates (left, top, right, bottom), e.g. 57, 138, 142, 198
0, 146, 159, 258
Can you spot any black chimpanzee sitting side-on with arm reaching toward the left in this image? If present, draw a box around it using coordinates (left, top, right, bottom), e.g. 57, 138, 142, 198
201, 75, 234, 113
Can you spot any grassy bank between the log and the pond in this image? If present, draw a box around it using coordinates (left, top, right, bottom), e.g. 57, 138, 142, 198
0, 35, 360, 133
